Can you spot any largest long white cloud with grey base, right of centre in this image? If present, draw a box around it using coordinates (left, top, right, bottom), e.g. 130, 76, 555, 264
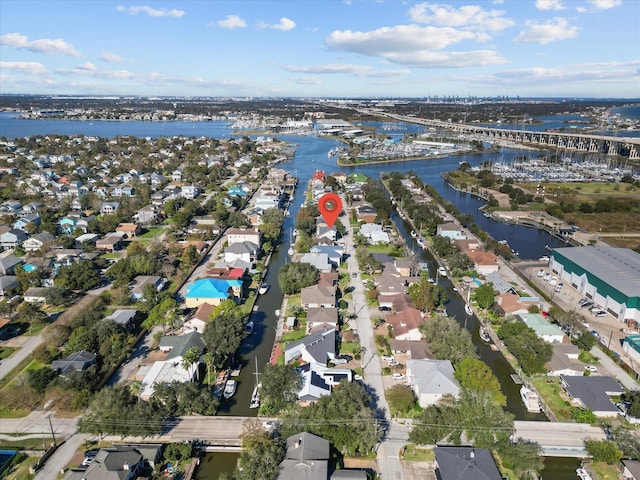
326, 25, 506, 68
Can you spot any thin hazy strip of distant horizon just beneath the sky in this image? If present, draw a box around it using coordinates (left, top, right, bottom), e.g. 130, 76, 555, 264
0, 93, 640, 103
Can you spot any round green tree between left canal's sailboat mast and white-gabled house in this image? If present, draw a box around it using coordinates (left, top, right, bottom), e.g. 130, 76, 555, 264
260, 364, 302, 415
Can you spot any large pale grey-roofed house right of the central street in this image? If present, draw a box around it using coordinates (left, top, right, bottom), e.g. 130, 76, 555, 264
407, 359, 461, 408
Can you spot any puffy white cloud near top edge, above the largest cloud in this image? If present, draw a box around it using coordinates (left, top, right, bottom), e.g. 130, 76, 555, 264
409, 3, 514, 31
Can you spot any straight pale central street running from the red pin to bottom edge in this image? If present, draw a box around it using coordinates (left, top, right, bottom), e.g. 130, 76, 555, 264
338, 202, 410, 480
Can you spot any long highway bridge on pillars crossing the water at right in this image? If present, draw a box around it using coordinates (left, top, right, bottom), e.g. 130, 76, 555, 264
376, 111, 640, 160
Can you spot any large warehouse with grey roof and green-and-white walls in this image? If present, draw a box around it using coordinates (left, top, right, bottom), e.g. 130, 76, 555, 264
549, 246, 640, 323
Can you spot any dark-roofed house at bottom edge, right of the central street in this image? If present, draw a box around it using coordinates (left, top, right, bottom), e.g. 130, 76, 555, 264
433, 447, 502, 480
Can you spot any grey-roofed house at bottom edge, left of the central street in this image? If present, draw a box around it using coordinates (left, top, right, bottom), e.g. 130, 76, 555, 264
278, 432, 330, 480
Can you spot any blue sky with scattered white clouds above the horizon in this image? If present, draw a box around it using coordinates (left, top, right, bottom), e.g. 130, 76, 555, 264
0, 0, 640, 98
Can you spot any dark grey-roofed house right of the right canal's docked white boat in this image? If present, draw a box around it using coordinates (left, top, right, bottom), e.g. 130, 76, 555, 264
560, 375, 624, 418
